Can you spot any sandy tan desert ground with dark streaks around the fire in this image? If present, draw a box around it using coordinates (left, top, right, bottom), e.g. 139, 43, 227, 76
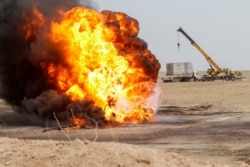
0, 71, 250, 167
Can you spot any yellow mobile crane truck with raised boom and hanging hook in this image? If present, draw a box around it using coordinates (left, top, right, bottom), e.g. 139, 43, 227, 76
177, 27, 245, 81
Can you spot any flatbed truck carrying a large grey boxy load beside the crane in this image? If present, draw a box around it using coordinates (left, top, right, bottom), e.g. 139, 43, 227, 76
161, 62, 198, 82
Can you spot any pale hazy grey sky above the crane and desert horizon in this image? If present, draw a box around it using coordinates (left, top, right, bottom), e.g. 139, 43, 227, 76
94, 0, 250, 71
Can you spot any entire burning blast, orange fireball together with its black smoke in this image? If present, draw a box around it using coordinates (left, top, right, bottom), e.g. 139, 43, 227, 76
0, 0, 160, 127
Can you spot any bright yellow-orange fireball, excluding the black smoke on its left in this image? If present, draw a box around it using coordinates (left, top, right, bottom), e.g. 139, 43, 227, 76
24, 7, 160, 126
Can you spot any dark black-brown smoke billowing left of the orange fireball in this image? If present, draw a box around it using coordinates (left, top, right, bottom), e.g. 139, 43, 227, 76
0, 0, 101, 122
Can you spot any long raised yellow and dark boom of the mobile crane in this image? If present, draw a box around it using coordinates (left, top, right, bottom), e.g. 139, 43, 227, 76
177, 27, 225, 76
